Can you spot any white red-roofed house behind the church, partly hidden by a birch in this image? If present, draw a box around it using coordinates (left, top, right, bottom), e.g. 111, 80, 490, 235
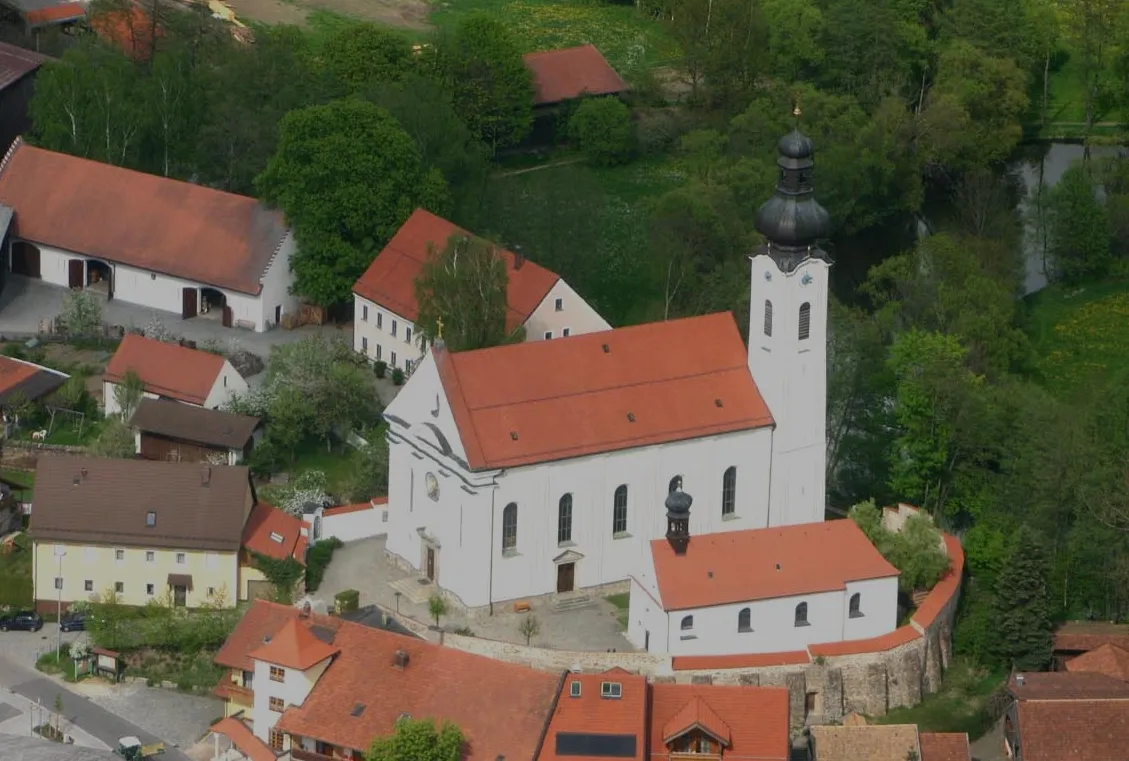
353, 209, 611, 373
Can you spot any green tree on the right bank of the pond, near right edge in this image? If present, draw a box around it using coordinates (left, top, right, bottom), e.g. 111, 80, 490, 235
1048, 163, 1113, 283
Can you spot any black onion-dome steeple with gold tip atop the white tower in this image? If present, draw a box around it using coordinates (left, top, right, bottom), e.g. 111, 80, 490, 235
755, 106, 831, 272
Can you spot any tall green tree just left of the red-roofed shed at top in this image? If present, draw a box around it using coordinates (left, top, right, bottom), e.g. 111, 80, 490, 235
436, 16, 533, 151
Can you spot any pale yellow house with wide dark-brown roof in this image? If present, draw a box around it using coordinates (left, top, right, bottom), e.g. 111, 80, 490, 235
29, 456, 291, 612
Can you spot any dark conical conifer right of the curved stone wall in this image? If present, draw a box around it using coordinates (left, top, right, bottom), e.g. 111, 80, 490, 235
994, 527, 1054, 671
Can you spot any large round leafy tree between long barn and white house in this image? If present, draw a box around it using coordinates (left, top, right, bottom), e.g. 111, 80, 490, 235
255, 100, 447, 306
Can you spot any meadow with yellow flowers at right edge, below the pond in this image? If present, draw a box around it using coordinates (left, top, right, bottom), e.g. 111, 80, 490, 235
1026, 280, 1129, 394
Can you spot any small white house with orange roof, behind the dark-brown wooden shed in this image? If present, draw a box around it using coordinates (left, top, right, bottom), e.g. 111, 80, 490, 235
102, 333, 247, 418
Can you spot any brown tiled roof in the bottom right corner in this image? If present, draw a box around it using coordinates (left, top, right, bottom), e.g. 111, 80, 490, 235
1020, 700, 1129, 761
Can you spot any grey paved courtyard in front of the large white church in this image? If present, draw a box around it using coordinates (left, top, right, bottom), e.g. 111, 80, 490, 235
314, 536, 634, 651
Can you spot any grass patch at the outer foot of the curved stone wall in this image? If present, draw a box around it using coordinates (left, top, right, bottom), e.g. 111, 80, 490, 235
874, 658, 1005, 740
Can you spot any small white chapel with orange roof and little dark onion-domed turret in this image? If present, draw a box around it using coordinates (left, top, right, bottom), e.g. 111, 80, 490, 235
628, 510, 898, 656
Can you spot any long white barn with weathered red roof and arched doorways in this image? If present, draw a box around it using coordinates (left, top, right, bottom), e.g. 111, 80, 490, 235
0, 140, 298, 332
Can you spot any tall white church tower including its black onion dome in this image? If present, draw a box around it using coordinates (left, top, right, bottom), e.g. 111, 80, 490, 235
749, 114, 831, 526
